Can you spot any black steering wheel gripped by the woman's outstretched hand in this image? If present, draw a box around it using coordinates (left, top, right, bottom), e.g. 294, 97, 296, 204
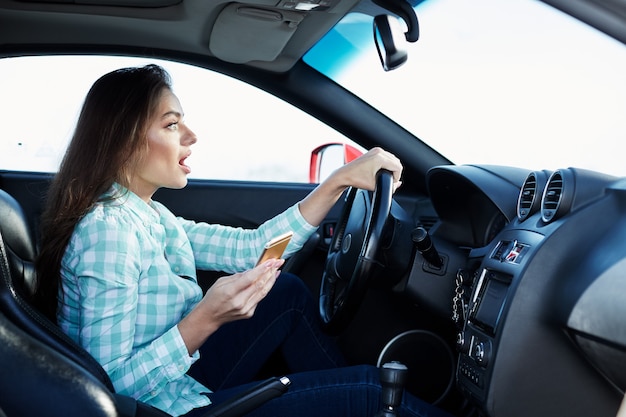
319, 170, 393, 334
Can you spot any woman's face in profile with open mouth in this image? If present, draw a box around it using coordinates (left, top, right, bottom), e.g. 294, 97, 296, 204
129, 89, 197, 202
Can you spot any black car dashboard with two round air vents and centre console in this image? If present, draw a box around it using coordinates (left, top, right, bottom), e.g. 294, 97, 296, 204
404, 166, 626, 417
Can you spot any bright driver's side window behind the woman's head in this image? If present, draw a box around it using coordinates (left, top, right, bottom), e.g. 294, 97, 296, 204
0, 56, 362, 182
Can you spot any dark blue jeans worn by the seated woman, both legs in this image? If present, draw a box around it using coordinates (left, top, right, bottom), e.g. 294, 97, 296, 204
186, 274, 448, 417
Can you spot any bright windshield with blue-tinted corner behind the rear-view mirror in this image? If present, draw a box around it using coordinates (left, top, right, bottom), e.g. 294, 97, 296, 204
305, 0, 626, 176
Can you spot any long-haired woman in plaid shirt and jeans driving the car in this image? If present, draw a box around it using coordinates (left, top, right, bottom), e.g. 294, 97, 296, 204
36, 65, 448, 417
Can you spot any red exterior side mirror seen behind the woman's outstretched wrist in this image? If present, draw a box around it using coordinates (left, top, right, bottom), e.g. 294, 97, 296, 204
309, 142, 363, 184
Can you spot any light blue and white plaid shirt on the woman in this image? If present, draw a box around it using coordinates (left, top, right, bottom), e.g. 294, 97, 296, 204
57, 184, 315, 415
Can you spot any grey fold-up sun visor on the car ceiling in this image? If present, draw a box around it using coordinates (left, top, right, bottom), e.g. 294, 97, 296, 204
209, 3, 305, 64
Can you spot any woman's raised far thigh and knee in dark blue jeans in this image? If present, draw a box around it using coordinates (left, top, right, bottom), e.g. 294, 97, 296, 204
188, 273, 345, 391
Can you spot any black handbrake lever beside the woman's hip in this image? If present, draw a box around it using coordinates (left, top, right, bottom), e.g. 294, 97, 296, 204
204, 376, 291, 417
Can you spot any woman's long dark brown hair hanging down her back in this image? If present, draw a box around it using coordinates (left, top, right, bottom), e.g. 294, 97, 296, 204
34, 65, 172, 322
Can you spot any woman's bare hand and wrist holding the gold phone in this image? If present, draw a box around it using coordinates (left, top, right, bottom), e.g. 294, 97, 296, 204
178, 259, 285, 354
